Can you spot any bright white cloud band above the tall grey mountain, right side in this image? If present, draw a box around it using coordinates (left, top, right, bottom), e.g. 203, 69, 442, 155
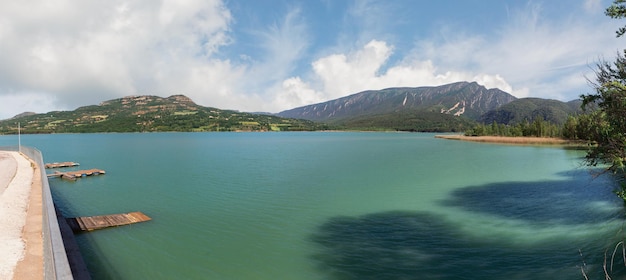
272, 0, 620, 110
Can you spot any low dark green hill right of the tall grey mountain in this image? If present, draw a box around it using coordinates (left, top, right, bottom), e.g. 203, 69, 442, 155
479, 98, 582, 124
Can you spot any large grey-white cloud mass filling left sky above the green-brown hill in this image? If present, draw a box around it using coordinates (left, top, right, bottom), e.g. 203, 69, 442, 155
0, 0, 316, 119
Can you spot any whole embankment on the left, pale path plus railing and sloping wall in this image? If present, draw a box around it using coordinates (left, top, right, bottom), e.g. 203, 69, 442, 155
0, 147, 91, 280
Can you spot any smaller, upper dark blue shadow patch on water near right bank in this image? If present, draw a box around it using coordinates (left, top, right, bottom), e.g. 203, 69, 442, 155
442, 172, 624, 226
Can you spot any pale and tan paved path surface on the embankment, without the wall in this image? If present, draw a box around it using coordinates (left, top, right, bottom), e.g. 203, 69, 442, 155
0, 151, 43, 279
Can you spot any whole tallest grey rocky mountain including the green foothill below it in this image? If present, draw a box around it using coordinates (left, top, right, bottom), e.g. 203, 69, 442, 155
278, 82, 516, 131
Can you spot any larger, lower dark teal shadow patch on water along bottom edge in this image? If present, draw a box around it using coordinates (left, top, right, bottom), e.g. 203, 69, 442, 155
312, 212, 615, 279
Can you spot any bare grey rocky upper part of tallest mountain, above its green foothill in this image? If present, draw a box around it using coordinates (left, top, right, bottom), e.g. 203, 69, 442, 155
278, 82, 516, 121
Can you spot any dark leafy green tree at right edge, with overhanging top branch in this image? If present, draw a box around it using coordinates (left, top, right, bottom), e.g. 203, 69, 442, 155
581, 0, 626, 175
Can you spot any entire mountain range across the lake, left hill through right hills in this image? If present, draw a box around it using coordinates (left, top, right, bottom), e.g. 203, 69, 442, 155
0, 82, 581, 134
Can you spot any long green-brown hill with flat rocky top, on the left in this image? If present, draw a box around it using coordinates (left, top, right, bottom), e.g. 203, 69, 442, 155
0, 95, 325, 134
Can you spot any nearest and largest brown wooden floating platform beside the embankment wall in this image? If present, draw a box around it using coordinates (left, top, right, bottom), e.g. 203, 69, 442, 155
67, 212, 152, 232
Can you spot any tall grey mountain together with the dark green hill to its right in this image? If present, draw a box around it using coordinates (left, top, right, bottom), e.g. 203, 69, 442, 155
278, 82, 581, 131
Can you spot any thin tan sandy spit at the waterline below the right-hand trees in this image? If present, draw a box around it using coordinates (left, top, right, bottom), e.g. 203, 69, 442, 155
435, 134, 586, 146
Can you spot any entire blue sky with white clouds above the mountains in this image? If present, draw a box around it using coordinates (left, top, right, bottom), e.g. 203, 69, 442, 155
0, 0, 626, 119
